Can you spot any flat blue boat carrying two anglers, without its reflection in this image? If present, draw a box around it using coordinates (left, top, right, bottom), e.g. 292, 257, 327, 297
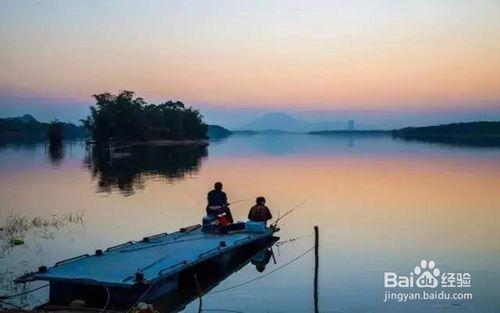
16, 225, 278, 307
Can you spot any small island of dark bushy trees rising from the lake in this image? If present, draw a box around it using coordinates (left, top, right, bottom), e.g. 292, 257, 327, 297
82, 91, 208, 145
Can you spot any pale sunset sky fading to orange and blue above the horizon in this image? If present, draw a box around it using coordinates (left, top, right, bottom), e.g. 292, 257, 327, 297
0, 0, 500, 126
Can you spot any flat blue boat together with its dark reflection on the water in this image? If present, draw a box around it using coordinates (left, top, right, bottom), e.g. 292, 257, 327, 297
17, 225, 278, 312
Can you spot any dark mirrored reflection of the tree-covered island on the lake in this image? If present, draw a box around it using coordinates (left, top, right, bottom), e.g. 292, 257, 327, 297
85, 145, 207, 195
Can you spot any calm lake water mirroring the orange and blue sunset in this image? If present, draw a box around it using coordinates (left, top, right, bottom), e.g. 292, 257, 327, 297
0, 135, 500, 312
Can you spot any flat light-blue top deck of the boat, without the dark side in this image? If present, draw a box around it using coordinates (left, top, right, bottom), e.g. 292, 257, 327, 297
17, 225, 273, 287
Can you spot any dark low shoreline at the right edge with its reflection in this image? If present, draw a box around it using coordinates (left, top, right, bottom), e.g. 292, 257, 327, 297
392, 122, 500, 147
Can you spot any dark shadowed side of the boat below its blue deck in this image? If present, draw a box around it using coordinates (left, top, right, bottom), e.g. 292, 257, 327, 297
37, 227, 278, 312
